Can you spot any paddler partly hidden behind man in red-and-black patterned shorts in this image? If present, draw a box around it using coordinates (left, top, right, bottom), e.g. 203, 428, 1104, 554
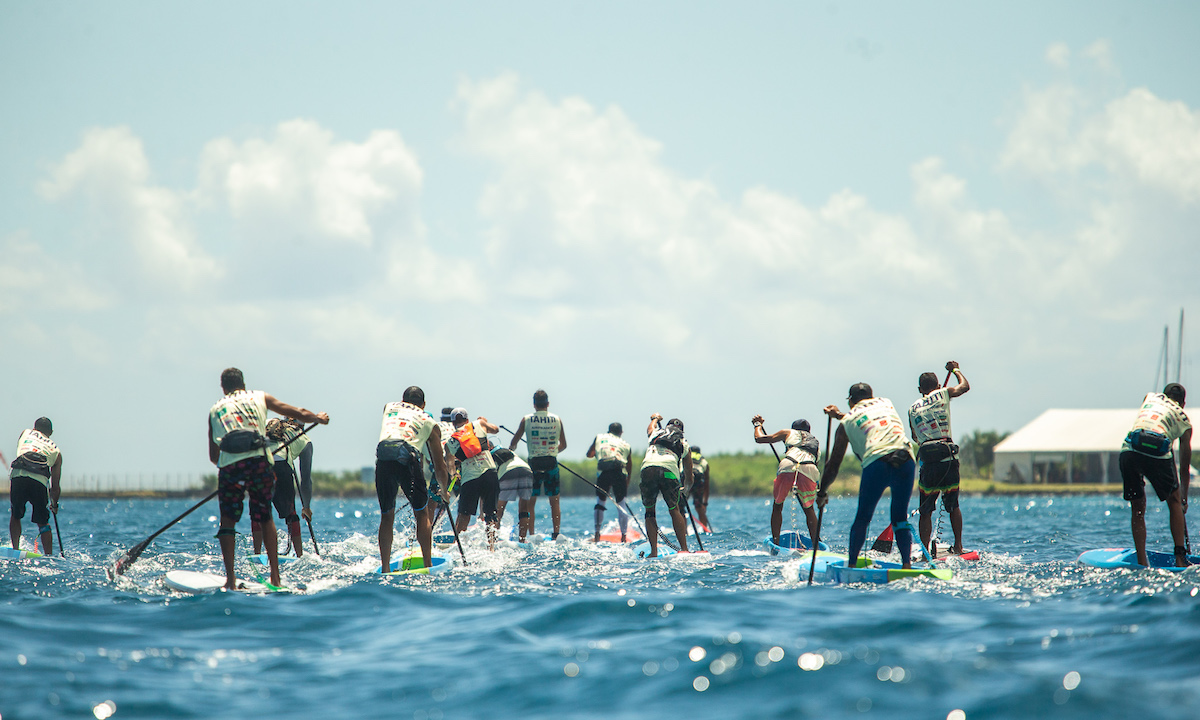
250, 418, 313, 558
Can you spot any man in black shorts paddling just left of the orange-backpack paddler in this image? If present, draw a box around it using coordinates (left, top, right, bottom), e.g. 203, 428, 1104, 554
376, 385, 450, 572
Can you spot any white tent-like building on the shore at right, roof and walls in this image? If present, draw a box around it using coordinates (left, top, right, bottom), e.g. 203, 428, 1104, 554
992, 408, 1138, 484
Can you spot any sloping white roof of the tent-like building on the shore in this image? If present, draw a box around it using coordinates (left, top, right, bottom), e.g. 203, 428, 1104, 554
996, 408, 1138, 452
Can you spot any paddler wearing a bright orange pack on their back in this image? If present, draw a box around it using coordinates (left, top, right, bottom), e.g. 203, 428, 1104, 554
445, 408, 500, 550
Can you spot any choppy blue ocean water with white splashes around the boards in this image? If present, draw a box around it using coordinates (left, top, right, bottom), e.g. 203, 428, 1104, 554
0, 496, 1200, 720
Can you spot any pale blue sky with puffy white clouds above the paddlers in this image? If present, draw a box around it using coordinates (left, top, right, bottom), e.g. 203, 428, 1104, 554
0, 1, 1200, 478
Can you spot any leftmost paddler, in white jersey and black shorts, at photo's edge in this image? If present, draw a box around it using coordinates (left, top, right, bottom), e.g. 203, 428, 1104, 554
8, 418, 62, 556
